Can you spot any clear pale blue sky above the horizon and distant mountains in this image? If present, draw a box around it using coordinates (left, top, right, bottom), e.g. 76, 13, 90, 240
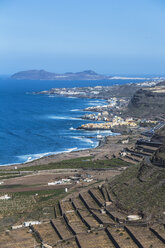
0, 0, 165, 75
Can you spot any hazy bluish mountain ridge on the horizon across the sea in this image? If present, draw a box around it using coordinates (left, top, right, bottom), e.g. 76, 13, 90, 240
11, 70, 108, 80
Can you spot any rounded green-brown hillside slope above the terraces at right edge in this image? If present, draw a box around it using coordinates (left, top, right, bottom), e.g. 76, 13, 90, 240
109, 128, 165, 222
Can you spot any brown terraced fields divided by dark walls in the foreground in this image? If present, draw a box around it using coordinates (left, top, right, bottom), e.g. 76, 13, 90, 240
0, 187, 165, 248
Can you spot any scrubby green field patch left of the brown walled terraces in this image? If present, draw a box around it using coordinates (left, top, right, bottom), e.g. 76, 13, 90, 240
0, 189, 67, 232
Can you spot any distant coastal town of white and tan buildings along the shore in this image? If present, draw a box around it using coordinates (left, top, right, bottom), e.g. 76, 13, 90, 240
33, 80, 164, 132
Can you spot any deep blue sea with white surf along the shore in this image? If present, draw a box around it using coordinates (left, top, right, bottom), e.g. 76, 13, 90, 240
0, 78, 146, 165
